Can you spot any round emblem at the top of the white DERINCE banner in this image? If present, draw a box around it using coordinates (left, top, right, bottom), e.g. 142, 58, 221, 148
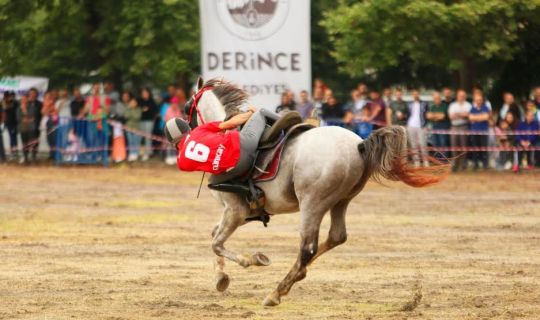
215, 0, 290, 41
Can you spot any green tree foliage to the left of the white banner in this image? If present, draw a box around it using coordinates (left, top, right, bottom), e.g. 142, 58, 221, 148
0, 0, 199, 86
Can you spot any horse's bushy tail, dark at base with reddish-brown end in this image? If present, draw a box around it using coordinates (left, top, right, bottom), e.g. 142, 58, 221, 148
358, 126, 450, 187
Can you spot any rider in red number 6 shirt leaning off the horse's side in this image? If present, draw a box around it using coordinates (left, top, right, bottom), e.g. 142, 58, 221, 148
165, 107, 279, 196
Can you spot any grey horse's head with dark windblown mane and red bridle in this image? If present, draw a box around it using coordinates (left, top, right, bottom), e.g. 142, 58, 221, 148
184, 77, 248, 128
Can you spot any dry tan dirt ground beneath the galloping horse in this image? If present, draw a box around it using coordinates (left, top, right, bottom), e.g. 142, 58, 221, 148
0, 166, 540, 319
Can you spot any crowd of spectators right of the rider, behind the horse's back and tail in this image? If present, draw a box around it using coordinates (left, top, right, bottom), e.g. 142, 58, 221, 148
276, 79, 540, 172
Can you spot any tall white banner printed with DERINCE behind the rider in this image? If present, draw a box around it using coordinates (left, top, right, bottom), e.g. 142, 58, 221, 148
199, 0, 311, 110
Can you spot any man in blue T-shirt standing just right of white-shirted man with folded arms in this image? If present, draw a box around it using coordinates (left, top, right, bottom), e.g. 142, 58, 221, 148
469, 92, 491, 170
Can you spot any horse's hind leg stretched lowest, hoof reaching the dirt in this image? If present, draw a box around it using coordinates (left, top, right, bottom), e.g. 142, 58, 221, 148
263, 206, 327, 306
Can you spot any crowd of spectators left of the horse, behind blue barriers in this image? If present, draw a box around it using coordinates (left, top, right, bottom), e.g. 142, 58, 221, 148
0, 82, 186, 164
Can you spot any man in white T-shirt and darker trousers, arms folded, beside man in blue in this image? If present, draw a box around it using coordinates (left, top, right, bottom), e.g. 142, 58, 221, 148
448, 89, 472, 172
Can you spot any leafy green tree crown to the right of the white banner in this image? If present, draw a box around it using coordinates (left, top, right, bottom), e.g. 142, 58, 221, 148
322, 0, 540, 89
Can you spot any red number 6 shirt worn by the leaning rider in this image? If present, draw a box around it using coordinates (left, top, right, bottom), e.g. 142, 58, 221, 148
177, 121, 240, 174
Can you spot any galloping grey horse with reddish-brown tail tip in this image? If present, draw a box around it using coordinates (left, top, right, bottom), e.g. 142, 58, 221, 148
182, 79, 448, 306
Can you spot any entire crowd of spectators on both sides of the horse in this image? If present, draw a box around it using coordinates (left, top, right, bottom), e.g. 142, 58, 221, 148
0, 79, 540, 172
